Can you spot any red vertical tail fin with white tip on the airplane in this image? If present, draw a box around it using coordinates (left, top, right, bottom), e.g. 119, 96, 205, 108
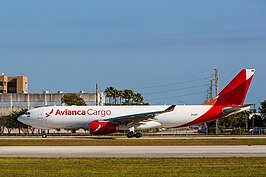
205, 69, 255, 106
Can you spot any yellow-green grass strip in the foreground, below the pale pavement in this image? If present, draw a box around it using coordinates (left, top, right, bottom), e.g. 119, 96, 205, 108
0, 158, 266, 177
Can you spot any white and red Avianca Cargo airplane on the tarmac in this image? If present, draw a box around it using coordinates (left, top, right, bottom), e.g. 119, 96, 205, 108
18, 69, 255, 138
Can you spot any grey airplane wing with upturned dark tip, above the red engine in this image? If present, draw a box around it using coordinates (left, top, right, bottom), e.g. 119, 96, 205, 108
105, 105, 175, 124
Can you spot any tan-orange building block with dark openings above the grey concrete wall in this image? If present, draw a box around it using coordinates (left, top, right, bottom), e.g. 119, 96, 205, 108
0, 76, 28, 94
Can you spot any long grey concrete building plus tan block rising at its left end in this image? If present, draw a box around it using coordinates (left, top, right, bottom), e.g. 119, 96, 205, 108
0, 74, 105, 116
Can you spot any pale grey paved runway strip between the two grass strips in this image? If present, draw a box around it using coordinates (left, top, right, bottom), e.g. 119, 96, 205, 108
0, 145, 266, 158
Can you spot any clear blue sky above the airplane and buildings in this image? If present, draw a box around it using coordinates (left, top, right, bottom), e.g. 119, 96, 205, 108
0, 0, 266, 105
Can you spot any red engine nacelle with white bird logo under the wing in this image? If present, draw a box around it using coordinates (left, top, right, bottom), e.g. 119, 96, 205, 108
90, 121, 117, 135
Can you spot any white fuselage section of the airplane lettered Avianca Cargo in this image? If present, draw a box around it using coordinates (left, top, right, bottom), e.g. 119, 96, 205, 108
19, 105, 212, 130
